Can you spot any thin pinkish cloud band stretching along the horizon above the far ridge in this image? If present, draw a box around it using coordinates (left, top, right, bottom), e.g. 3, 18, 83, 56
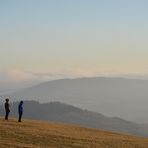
0, 69, 148, 82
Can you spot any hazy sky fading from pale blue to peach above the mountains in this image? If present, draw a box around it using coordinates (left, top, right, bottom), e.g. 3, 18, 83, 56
0, 0, 148, 80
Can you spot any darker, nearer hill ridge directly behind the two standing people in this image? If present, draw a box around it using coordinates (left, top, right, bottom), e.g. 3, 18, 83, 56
0, 101, 148, 137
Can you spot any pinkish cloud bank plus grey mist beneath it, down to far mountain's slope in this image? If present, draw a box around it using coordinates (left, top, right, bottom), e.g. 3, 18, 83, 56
0, 69, 148, 93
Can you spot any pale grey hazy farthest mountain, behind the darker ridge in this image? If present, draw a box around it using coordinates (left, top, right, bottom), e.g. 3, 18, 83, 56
2, 77, 148, 123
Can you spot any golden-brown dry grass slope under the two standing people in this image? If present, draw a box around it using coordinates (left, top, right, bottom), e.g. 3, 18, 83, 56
0, 118, 148, 148
